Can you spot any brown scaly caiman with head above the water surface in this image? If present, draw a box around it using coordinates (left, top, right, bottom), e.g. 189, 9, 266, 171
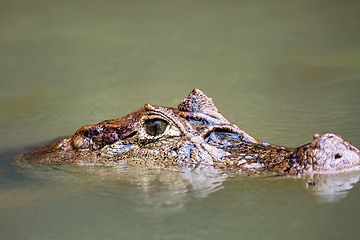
17, 89, 360, 174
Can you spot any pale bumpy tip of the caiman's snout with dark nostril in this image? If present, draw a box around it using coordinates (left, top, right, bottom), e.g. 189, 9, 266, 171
306, 133, 360, 173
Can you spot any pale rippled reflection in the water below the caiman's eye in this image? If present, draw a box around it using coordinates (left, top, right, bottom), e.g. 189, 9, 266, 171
83, 165, 227, 214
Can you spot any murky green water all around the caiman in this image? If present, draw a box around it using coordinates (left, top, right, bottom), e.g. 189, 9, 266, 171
0, 0, 360, 239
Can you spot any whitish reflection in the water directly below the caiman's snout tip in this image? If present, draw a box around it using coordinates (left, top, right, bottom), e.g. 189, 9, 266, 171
307, 171, 360, 202
